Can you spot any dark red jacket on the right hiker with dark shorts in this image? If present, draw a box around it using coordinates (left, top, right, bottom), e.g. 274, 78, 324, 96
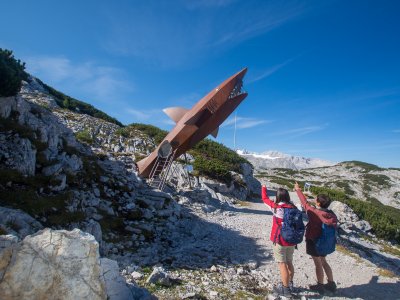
297, 190, 337, 240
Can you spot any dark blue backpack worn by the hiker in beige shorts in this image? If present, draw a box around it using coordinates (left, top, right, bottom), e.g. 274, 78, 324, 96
281, 207, 305, 244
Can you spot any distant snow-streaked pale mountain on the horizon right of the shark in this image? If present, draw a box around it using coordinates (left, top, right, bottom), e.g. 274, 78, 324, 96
236, 150, 336, 171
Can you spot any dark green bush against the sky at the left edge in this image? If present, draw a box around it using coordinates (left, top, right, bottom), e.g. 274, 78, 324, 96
0, 48, 27, 97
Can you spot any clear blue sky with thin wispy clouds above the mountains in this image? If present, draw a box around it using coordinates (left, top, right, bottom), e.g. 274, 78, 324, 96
0, 0, 400, 167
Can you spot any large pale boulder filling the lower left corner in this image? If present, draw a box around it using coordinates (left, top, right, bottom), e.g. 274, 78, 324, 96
0, 229, 149, 300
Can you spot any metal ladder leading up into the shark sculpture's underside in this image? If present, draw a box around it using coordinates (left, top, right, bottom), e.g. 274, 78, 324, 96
149, 148, 176, 191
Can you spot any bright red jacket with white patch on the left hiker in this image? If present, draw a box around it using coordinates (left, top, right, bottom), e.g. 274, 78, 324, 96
261, 186, 295, 246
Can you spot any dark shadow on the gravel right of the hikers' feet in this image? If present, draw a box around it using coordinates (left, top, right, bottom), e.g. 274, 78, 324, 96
337, 276, 400, 300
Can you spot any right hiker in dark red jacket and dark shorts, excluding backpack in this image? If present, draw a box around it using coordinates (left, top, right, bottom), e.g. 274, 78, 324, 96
294, 182, 337, 293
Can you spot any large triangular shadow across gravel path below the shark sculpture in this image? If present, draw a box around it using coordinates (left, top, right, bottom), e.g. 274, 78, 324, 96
132, 207, 272, 269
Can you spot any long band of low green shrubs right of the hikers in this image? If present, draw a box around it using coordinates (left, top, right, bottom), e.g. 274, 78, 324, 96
311, 186, 400, 243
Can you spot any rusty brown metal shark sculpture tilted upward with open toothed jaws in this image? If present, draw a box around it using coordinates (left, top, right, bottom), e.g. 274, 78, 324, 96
137, 68, 247, 177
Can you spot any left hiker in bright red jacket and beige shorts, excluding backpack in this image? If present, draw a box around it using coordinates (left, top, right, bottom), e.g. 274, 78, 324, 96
261, 185, 295, 297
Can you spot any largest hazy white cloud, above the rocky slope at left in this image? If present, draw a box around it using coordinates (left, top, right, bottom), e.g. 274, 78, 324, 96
26, 56, 133, 101
